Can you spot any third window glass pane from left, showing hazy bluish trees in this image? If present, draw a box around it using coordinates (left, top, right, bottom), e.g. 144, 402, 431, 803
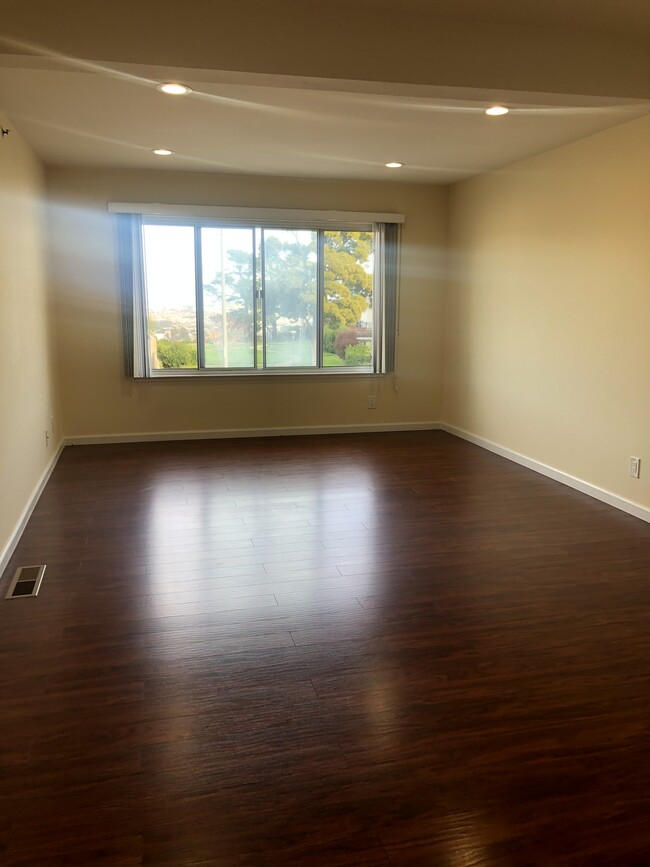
263, 229, 318, 367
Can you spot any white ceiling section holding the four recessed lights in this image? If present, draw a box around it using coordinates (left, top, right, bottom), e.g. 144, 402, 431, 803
0, 54, 649, 183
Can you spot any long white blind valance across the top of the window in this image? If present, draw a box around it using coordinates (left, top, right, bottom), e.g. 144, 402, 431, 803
108, 202, 405, 225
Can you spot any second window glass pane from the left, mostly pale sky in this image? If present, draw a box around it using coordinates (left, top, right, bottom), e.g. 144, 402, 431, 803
201, 227, 255, 368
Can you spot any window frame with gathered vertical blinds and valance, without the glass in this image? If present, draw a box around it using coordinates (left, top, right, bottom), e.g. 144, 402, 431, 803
115, 203, 404, 381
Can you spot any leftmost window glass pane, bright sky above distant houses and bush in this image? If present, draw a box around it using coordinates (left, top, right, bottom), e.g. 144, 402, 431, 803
142, 226, 197, 370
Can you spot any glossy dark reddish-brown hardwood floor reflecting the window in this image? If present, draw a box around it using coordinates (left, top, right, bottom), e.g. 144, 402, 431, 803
0, 432, 650, 867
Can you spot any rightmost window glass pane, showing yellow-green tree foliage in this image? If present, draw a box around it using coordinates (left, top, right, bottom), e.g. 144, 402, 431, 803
322, 230, 373, 367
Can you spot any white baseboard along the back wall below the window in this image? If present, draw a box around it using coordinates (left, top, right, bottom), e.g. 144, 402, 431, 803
64, 421, 440, 446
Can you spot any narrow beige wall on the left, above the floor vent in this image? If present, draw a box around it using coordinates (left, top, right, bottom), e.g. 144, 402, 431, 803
0, 114, 60, 571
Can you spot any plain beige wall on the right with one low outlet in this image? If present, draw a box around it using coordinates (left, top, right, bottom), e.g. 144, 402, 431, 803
443, 118, 650, 507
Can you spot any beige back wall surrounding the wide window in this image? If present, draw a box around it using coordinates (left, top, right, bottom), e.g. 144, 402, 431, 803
48, 169, 447, 437
